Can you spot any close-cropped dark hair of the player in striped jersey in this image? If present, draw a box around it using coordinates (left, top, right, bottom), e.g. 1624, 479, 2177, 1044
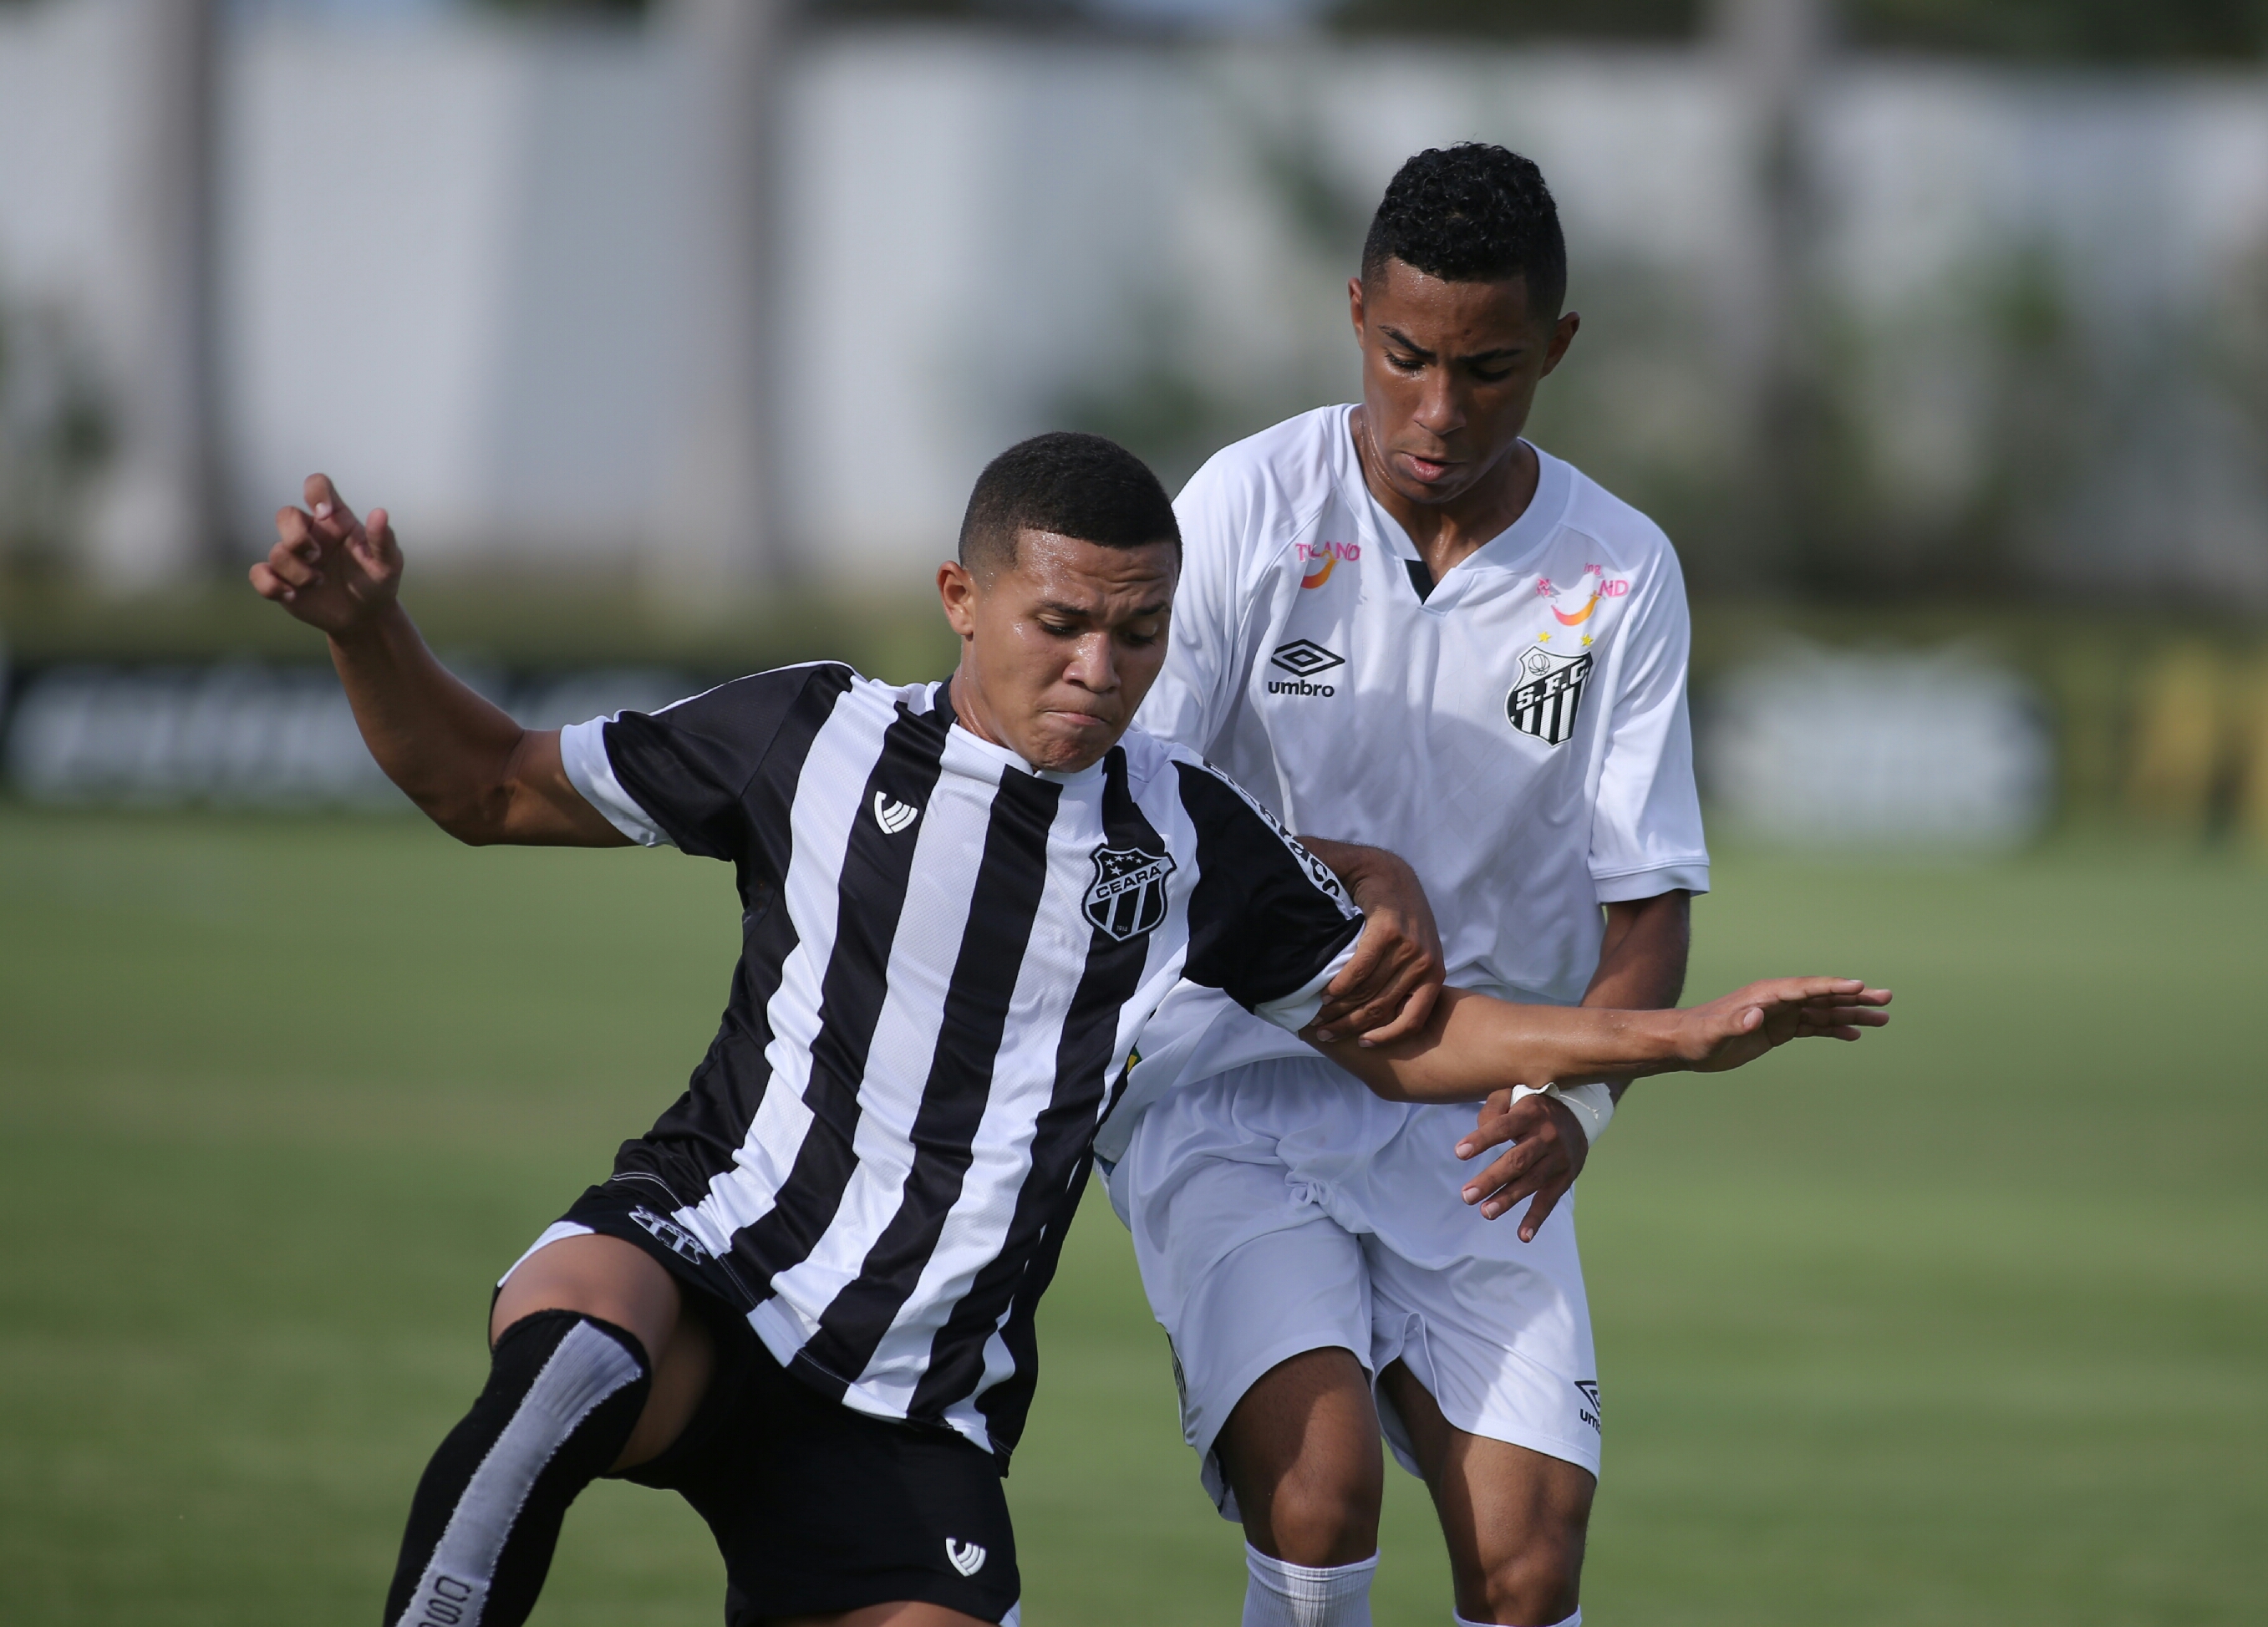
959, 429, 1182, 572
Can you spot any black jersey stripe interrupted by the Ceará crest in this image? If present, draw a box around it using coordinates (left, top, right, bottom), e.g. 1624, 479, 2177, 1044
908, 746, 1166, 1459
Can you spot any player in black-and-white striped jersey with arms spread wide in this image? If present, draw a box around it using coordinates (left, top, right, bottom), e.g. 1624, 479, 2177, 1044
252, 435, 1887, 1627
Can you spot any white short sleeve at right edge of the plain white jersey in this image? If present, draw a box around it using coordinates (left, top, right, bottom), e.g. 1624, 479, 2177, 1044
1590, 547, 1708, 903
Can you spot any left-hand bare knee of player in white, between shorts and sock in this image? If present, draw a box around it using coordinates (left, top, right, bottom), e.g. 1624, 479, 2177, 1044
1216, 1345, 1386, 1568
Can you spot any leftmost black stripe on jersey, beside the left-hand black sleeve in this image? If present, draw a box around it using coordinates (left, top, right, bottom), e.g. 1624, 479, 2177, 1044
614, 663, 852, 1208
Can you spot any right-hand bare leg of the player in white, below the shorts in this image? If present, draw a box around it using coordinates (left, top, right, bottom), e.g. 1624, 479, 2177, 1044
1381, 1361, 1599, 1627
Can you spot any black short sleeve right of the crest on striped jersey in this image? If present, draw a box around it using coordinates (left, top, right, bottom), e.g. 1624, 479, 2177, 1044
1175, 762, 1363, 1033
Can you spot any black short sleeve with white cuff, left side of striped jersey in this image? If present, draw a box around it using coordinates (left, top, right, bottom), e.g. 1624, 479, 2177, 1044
560, 663, 852, 860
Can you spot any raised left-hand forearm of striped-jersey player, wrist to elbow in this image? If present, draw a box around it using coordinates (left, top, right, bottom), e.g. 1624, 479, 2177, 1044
331, 603, 528, 841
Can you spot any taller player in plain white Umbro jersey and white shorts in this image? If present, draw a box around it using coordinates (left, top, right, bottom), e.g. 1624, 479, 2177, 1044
1098, 145, 1708, 1627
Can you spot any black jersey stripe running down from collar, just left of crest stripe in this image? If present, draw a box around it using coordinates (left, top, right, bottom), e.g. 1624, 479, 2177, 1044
801, 770, 1064, 1373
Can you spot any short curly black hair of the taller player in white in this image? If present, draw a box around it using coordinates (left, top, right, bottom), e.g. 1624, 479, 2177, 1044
1363, 140, 1567, 318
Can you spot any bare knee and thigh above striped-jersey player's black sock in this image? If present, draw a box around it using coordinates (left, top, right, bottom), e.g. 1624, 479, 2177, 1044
488, 1233, 717, 1468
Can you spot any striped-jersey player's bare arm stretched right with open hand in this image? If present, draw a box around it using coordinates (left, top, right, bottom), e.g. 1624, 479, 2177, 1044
1306, 978, 1889, 1101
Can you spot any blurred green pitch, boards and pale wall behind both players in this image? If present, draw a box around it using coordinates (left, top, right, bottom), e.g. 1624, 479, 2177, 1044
0, 0, 2268, 1624
